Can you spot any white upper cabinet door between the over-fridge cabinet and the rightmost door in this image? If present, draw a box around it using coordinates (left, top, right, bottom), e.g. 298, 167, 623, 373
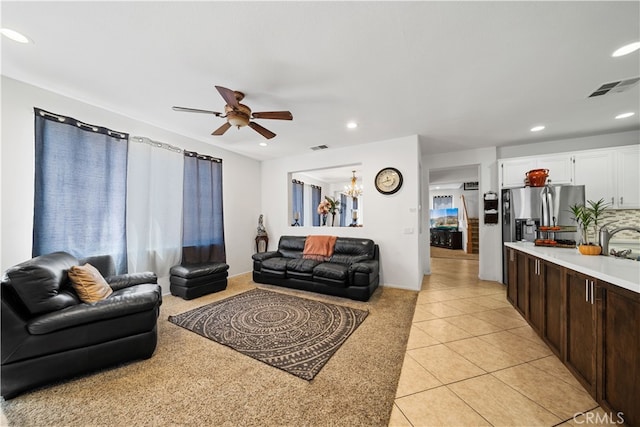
574, 150, 616, 204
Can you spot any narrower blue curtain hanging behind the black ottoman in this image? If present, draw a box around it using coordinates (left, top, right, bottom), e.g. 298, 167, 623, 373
182, 151, 227, 264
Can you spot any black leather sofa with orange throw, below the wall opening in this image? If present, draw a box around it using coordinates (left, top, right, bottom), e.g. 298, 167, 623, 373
253, 236, 380, 301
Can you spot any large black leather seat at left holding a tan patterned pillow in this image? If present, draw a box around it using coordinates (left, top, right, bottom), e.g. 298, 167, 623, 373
0, 252, 162, 399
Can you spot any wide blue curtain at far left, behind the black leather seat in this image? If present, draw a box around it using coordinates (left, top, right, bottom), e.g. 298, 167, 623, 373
32, 108, 129, 274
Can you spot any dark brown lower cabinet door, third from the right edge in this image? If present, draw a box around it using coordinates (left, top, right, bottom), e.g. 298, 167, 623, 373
541, 261, 564, 357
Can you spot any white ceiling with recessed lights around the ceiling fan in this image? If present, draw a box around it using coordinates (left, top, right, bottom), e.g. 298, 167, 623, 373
1, 1, 640, 159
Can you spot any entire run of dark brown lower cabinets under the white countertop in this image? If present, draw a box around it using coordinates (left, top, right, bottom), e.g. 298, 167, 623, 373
507, 244, 640, 427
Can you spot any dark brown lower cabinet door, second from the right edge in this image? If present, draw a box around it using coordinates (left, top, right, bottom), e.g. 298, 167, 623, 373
565, 270, 596, 397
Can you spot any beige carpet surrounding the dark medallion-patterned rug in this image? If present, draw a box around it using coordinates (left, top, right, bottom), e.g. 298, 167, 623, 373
1, 274, 417, 426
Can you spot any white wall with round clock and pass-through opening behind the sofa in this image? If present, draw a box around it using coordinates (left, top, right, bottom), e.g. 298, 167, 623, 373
262, 135, 422, 290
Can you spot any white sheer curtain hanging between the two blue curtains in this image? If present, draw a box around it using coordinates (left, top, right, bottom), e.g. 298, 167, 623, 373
127, 137, 184, 283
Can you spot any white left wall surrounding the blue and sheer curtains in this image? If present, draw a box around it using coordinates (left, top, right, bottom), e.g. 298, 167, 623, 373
0, 76, 261, 291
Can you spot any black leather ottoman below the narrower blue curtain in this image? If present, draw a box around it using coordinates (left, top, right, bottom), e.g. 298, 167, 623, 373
169, 262, 229, 299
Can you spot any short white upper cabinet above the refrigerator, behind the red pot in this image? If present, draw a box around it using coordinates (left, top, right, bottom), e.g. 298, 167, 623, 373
499, 153, 573, 188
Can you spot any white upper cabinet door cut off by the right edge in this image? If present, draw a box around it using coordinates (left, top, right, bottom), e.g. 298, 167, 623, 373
616, 145, 640, 209
